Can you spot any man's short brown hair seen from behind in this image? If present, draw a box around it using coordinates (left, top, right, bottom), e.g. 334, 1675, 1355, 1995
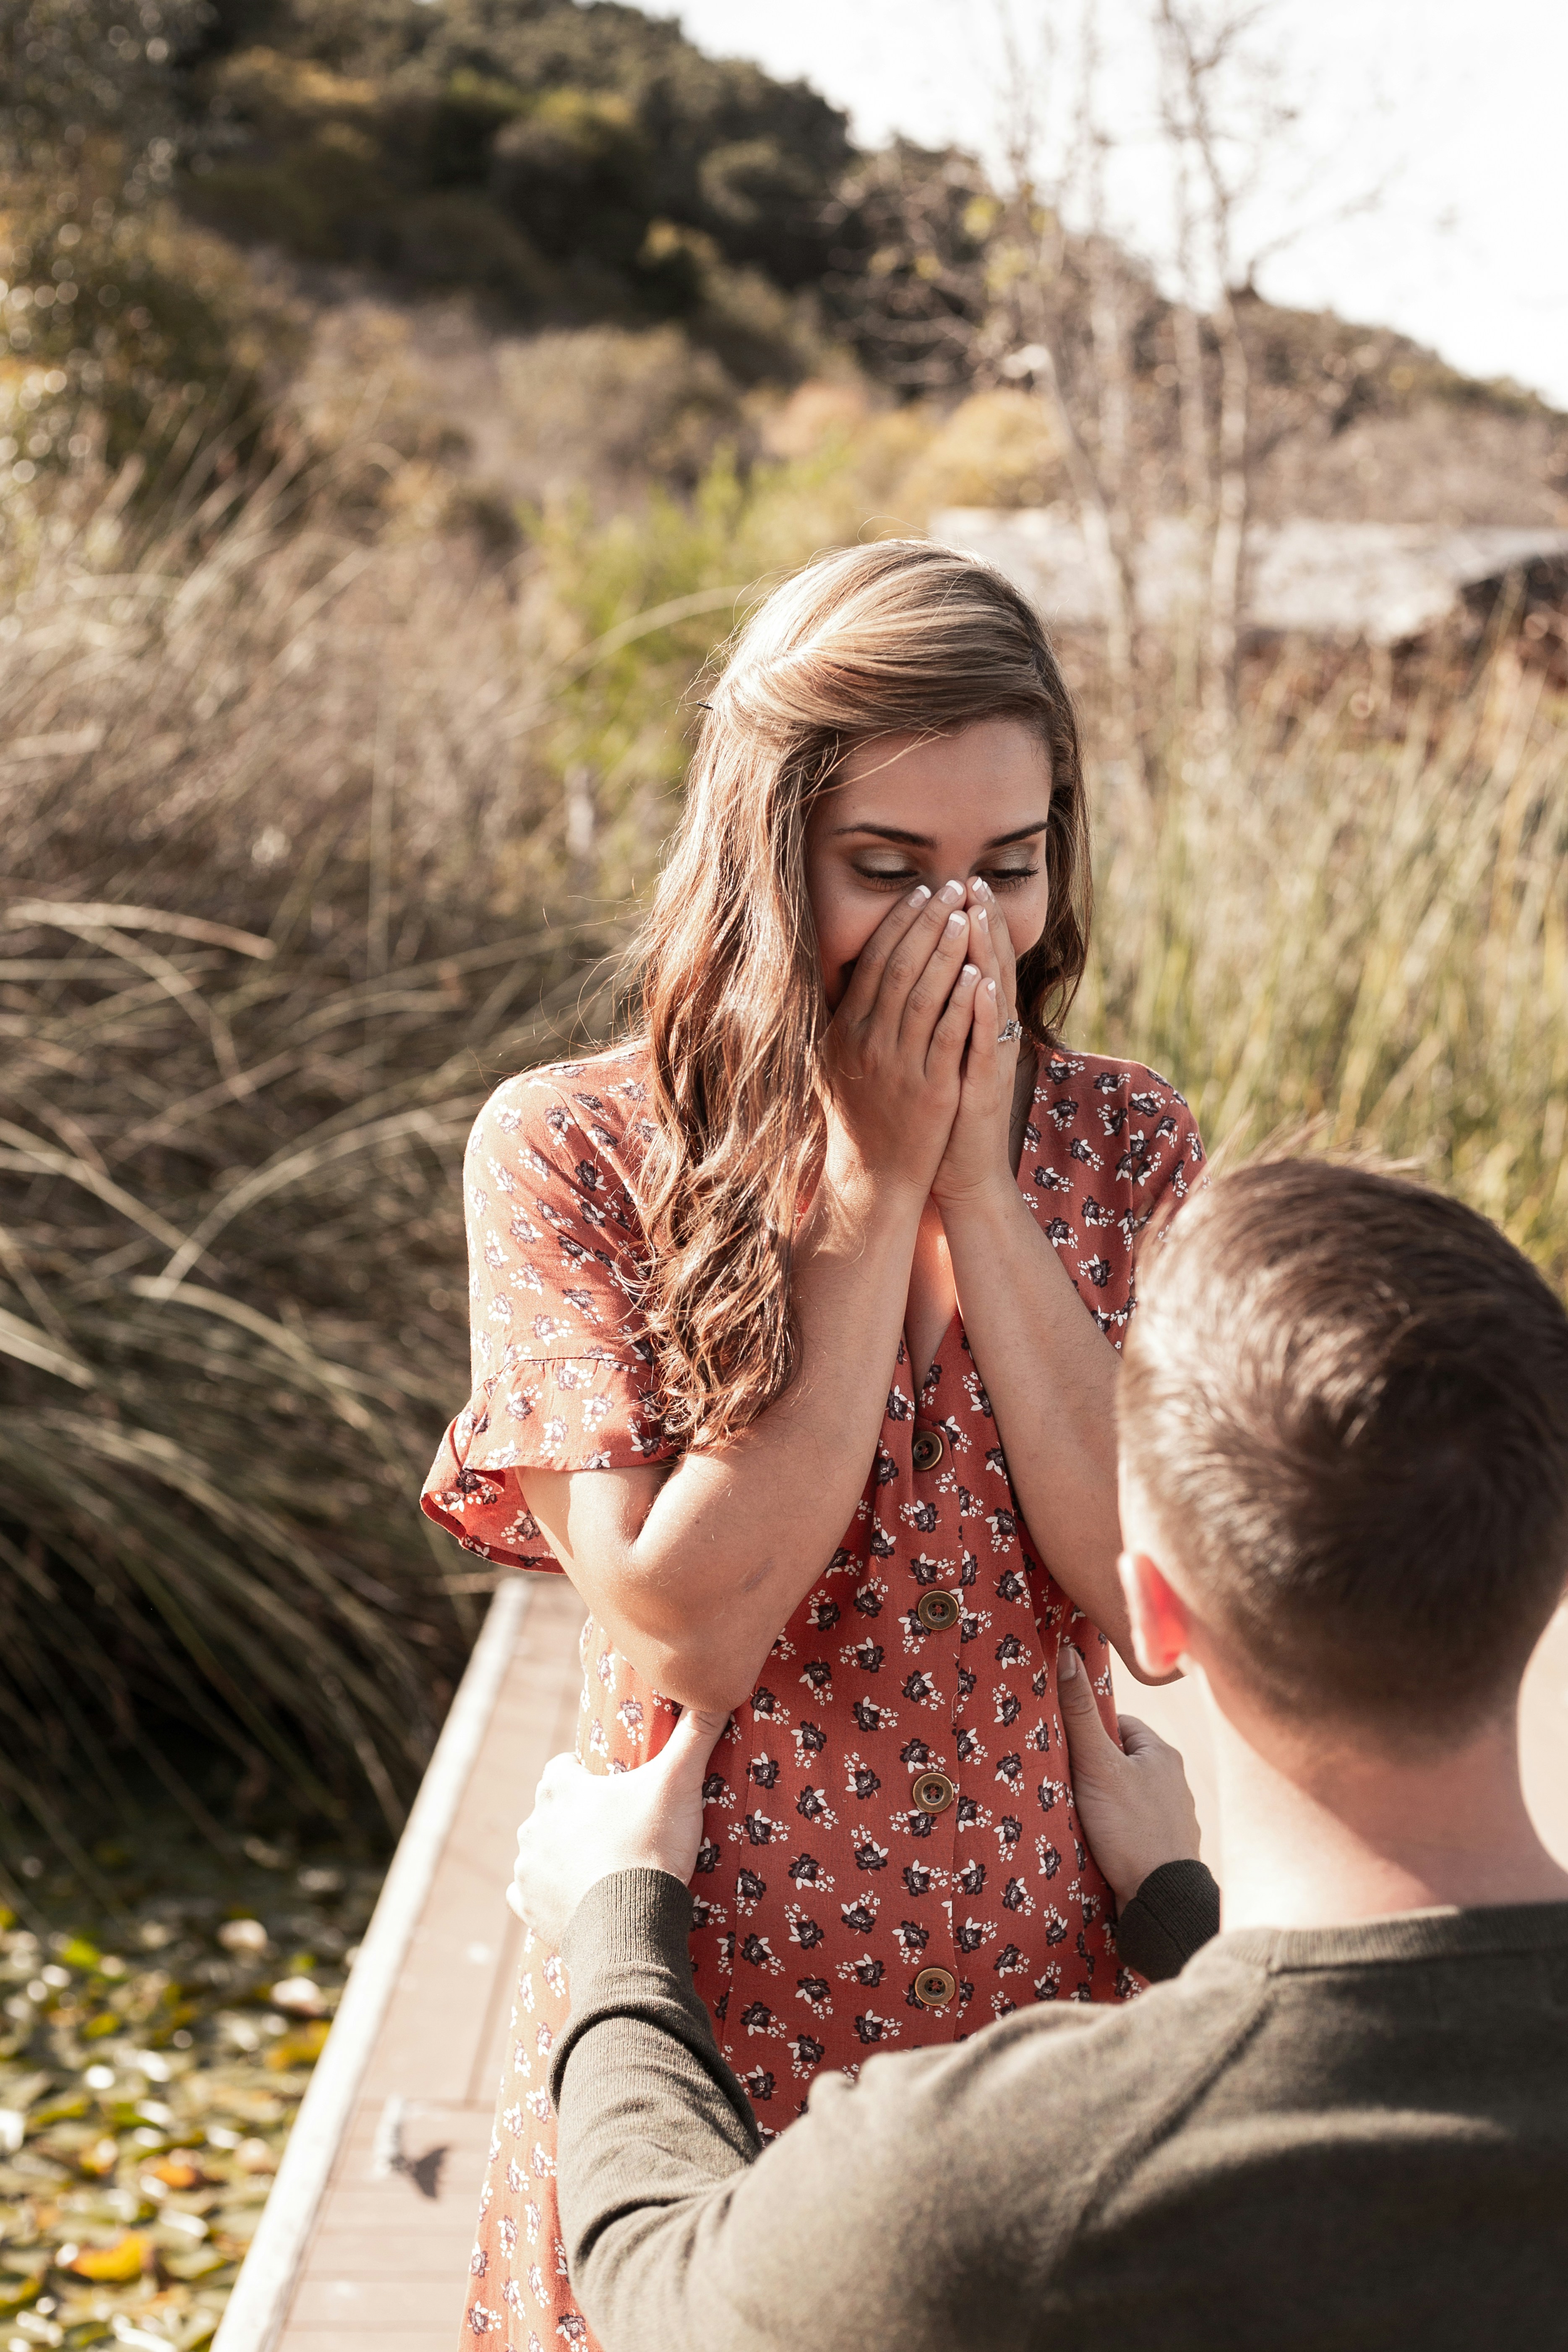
1119, 1159, 1568, 1738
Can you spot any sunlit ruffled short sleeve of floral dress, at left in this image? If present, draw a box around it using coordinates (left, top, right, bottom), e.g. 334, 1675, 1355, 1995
421, 1063, 675, 1569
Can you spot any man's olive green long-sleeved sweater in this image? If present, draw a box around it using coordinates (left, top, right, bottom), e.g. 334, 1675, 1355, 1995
553, 1870, 1568, 2352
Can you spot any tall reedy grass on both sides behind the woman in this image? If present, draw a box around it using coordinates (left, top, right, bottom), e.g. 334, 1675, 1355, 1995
0, 423, 1568, 1863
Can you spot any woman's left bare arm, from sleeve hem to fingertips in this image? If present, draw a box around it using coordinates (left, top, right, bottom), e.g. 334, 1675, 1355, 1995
522, 891, 978, 1712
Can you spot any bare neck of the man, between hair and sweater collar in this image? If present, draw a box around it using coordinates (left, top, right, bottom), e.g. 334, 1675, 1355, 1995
1208, 1689, 1568, 1929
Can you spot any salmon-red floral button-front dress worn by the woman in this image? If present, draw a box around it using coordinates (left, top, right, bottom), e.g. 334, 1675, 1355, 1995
423, 1047, 1204, 2352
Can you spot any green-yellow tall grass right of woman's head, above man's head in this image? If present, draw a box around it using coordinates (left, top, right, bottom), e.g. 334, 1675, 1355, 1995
1074, 647, 1568, 1284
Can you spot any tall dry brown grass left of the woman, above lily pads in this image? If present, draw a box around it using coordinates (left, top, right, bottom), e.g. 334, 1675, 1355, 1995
0, 449, 639, 1863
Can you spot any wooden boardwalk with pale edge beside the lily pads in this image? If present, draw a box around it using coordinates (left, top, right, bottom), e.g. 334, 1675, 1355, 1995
214, 1576, 1568, 2352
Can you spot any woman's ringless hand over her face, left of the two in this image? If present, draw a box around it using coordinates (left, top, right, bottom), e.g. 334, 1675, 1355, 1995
823, 882, 982, 1202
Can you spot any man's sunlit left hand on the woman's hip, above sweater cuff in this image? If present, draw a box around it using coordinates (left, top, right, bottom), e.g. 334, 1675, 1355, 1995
506, 1710, 729, 1952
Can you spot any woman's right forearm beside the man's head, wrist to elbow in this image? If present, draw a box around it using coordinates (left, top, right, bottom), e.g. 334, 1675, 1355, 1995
943, 1171, 1138, 1672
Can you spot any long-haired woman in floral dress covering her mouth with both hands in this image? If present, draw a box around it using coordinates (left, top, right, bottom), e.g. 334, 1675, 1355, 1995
425, 541, 1201, 2352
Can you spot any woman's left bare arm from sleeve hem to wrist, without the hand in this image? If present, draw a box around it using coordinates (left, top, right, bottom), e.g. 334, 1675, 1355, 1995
545, 1171, 921, 1707
